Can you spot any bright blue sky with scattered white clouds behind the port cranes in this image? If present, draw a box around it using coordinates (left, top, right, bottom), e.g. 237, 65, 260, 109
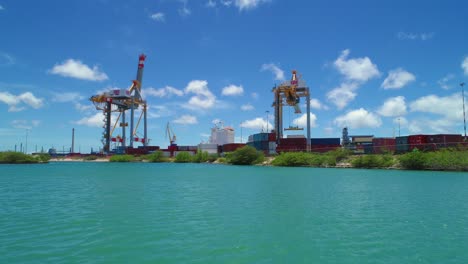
0, 0, 468, 152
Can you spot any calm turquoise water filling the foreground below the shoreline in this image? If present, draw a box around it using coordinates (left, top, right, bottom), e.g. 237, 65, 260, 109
0, 163, 468, 263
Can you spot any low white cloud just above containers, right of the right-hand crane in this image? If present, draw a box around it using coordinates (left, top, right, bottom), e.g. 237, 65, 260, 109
334, 108, 382, 129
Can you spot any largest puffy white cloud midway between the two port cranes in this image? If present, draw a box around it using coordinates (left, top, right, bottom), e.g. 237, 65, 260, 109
184, 80, 216, 110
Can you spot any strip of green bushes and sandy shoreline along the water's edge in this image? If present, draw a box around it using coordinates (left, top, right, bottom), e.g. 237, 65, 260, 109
10, 146, 468, 171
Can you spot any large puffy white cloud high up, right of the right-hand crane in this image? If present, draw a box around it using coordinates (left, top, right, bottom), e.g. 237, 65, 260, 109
334, 49, 380, 82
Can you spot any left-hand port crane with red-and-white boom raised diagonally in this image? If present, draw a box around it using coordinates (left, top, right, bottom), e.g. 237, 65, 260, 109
89, 54, 148, 153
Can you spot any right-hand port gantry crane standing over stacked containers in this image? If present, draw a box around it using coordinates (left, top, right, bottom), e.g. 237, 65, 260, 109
272, 70, 310, 151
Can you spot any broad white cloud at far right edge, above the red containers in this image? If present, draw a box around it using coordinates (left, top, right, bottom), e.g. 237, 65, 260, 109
410, 93, 463, 120
